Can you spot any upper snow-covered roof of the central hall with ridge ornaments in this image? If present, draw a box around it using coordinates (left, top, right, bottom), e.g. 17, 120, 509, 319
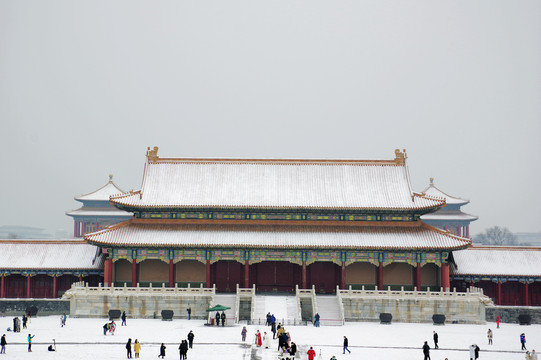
111, 150, 445, 210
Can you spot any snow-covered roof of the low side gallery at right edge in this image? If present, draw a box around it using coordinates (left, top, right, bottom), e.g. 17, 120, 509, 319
453, 246, 541, 276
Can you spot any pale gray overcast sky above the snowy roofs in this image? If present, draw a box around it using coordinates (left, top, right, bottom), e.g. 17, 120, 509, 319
0, 0, 541, 234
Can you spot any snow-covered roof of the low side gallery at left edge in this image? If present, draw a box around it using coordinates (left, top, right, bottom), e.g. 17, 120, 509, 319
0, 239, 103, 270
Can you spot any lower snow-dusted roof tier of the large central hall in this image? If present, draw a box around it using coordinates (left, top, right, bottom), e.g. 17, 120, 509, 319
84, 220, 471, 249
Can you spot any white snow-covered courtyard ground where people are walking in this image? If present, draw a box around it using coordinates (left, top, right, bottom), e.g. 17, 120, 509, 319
0, 316, 541, 360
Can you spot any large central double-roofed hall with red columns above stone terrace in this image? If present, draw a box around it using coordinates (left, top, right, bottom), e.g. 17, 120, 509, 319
84, 147, 471, 293
